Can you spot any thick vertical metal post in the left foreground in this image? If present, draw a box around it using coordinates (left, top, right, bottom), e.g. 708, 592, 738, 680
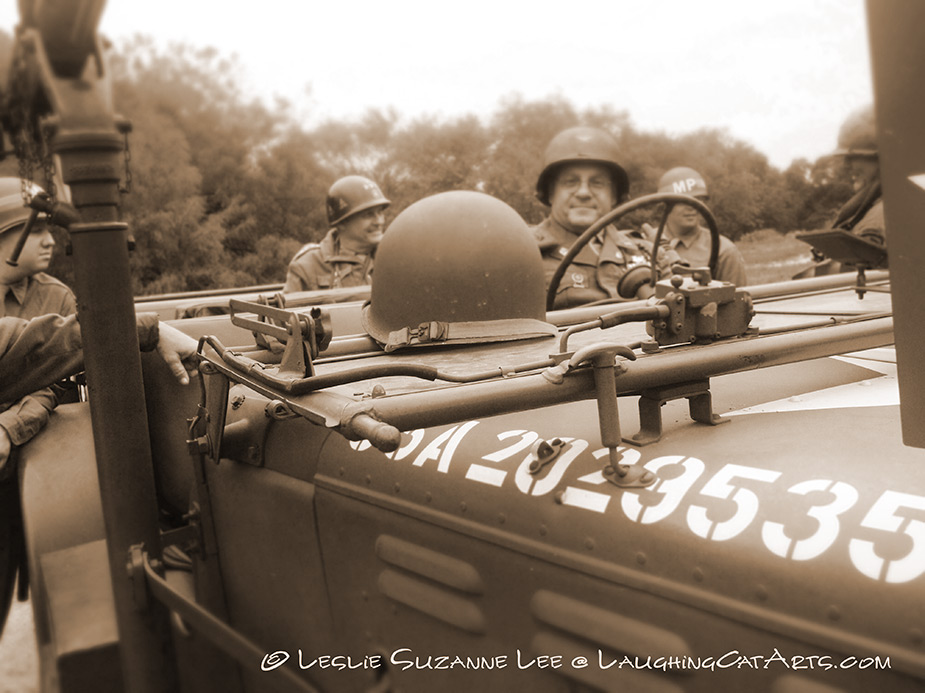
20, 14, 176, 693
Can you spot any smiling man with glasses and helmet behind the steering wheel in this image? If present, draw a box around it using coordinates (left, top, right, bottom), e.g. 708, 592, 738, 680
533, 127, 676, 308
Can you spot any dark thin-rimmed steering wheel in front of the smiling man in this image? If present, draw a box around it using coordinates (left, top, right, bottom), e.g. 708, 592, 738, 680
546, 193, 719, 310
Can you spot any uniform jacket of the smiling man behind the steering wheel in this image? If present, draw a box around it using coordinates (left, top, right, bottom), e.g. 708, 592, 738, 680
532, 217, 667, 309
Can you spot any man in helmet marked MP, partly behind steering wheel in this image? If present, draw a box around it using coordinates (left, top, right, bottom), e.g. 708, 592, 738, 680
658, 166, 747, 286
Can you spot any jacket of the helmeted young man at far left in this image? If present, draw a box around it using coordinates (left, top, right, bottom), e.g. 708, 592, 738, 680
0, 272, 77, 445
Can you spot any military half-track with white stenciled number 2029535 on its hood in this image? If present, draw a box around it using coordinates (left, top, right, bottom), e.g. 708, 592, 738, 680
5, 2, 925, 693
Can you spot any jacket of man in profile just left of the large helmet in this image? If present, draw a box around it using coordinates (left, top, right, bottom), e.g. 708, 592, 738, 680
283, 229, 373, 293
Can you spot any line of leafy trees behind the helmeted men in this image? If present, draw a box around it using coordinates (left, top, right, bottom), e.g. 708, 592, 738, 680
0, 36, 851, 295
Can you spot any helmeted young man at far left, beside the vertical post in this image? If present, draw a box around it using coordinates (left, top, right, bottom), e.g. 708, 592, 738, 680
0, 178, 77, 468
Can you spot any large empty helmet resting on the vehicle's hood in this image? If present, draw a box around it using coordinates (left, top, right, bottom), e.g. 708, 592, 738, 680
362, 190, 555, 351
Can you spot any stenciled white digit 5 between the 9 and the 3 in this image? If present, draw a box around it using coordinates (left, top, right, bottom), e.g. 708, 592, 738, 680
687, 464, 781, 541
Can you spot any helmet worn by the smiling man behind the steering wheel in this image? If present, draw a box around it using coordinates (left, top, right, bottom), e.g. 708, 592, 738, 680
536, 127, 630, 205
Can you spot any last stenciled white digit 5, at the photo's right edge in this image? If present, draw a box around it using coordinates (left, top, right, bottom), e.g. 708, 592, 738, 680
848, 491, 925, 582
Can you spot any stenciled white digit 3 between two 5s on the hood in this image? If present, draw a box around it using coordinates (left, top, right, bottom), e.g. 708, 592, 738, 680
761, 479, 858, 561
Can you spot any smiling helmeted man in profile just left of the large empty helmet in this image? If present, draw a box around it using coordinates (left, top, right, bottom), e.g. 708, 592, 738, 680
283, 176, 391, 293
